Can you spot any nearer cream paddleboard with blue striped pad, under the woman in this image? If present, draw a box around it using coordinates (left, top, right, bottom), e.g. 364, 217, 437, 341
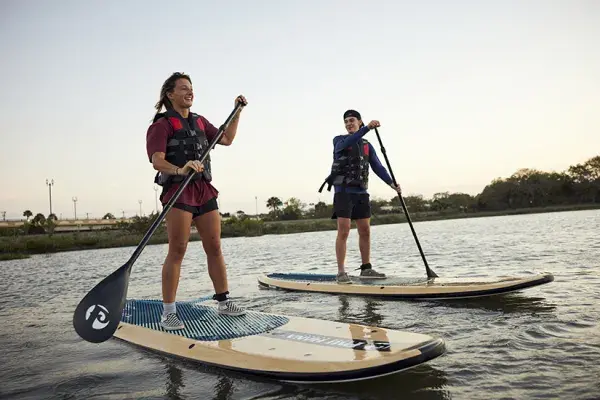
114, 299, 446, 383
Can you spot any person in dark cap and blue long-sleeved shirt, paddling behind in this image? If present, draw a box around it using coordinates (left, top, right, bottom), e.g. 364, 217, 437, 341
319, 110, 401, 283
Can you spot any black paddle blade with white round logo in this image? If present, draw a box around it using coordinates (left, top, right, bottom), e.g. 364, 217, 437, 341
73, 264, 131, 343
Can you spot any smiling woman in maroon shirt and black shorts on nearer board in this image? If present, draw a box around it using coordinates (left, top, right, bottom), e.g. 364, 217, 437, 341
146, 72, 247, 330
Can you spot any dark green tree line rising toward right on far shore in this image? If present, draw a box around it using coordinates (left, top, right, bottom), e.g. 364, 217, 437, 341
253, 156, 600, 220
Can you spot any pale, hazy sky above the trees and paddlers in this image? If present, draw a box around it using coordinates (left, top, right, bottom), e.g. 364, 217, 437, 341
0, 0, 600, 219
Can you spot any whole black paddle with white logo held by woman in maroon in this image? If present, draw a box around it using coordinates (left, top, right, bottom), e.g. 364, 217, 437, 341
73, 103, 245, 343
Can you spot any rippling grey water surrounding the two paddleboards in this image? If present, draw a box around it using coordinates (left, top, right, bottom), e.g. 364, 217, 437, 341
0, 211, 600, 400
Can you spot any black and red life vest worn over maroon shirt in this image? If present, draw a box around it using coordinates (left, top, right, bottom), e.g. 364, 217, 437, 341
154, 110, 212, 192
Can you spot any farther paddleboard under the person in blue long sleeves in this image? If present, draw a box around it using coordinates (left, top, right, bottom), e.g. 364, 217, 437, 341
258, 273, 554, 299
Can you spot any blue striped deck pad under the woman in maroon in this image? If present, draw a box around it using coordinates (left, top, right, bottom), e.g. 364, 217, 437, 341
121, 299, 289, 341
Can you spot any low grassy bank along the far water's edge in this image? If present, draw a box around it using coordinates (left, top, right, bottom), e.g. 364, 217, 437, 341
0, 204, 600, 260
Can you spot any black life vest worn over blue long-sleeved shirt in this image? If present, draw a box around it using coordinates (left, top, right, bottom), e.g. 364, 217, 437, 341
319, 138, 370, 193
